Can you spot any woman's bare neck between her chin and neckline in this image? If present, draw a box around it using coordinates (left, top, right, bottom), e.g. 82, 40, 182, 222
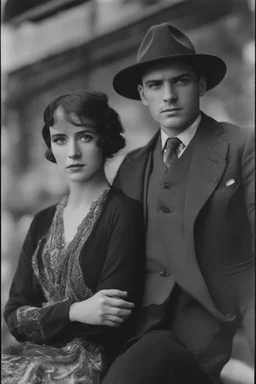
67, 174, 109, 209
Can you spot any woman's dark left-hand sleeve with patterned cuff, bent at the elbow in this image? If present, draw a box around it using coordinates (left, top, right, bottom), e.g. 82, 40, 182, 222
4, 214, 71, 344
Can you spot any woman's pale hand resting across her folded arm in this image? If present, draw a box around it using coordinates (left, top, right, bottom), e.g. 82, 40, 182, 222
69, 289, 134, 327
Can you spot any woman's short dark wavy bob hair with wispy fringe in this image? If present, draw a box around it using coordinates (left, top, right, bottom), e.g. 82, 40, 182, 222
42, 90, 125, 163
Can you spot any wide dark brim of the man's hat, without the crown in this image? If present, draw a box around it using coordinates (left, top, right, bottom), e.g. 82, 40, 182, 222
113, 53, 227, 100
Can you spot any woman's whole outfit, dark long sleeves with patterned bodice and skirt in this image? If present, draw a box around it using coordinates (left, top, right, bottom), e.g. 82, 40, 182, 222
2, 187, 144, 384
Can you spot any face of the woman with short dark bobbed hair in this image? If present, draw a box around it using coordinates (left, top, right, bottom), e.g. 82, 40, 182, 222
50, 107, 104, 182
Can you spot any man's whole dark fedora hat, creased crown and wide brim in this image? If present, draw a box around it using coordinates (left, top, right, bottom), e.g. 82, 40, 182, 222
113, 23, 227, 100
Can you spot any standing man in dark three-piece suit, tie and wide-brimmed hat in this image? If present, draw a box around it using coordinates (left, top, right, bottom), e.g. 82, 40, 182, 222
103, 23, 254, 384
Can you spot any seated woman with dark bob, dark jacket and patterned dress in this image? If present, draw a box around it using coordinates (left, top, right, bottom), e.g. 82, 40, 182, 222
2, 91, 144, 384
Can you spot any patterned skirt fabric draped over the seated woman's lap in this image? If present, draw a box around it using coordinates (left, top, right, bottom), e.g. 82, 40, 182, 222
1, 339, 102, 384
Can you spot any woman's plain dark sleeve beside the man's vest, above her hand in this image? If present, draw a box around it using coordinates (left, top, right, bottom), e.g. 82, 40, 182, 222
96, 200, 145, 304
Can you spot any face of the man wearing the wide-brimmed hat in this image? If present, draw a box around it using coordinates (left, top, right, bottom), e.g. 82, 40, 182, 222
138, 61, 207, 134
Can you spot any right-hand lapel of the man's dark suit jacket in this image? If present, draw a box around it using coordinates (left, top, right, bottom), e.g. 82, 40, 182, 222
179, 114, 234, 322
